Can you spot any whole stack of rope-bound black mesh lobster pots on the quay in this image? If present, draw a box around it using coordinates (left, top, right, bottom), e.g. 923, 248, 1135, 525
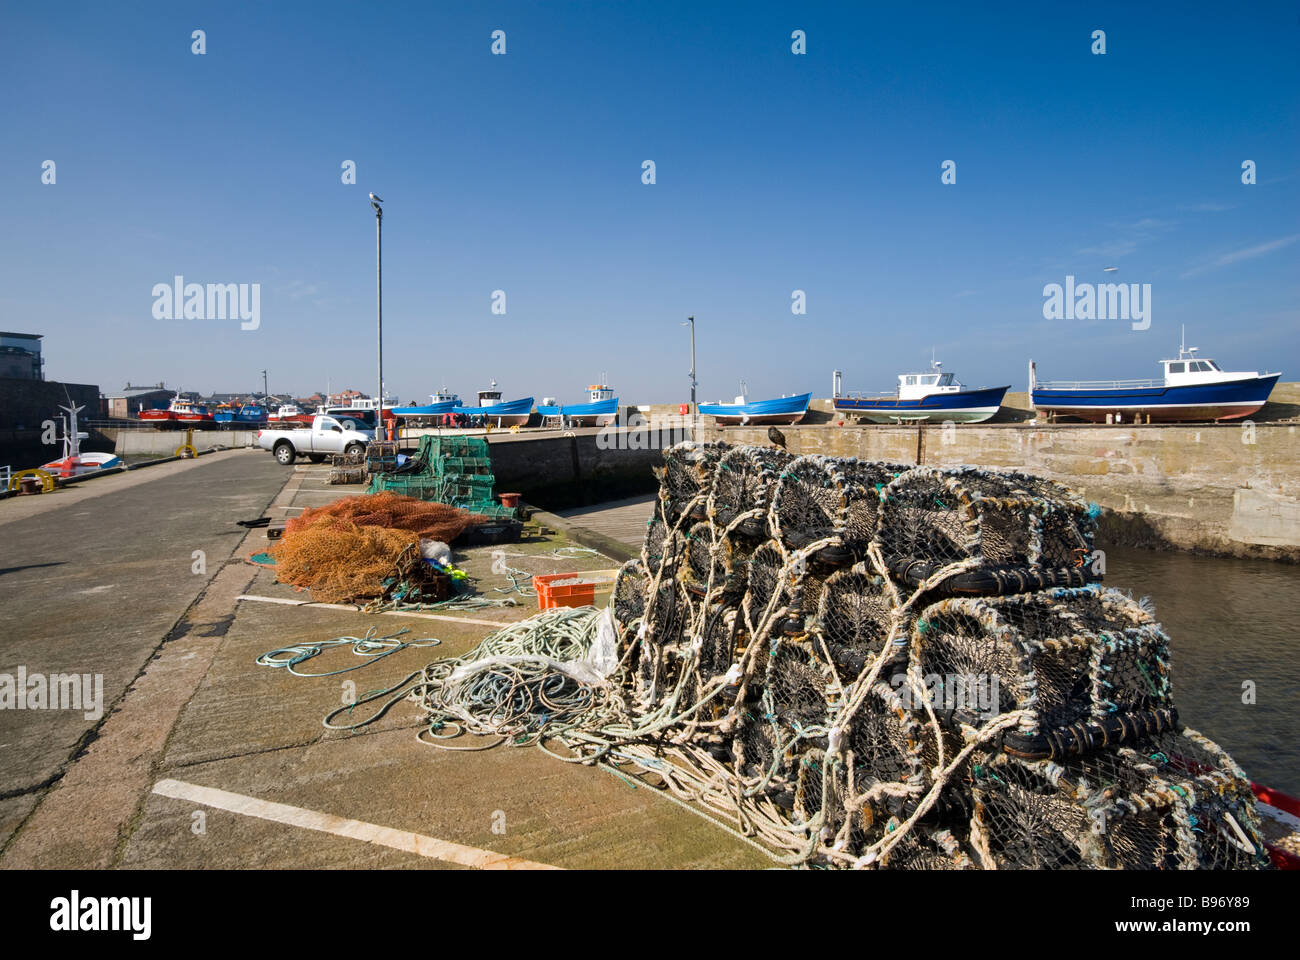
612, 442, 1269, 869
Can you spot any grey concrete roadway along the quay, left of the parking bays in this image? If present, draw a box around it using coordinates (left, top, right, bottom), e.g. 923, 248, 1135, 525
0, 453, 283, 796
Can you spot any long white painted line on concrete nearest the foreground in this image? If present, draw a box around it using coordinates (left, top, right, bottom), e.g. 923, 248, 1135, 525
153, 780, 562, 870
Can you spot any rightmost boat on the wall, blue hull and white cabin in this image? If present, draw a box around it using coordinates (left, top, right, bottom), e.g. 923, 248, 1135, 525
1030, 340, 1282, 423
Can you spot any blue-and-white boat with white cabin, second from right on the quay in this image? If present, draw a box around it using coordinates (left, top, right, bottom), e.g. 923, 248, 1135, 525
832, 360, 1011, 423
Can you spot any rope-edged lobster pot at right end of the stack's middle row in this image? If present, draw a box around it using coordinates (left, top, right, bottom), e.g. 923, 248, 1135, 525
910, 587, 1177, 760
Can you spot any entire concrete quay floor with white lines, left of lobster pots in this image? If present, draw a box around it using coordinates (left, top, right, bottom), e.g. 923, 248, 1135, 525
0, 450, 771, 869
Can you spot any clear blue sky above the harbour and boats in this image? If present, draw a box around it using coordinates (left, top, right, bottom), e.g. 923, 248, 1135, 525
0, 1, 1300, 402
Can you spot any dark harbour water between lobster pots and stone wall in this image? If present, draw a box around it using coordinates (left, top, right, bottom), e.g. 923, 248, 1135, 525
1105, 548, 1300, 795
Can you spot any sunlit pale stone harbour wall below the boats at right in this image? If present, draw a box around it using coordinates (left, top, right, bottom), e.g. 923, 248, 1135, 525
699, 423, 1300, 562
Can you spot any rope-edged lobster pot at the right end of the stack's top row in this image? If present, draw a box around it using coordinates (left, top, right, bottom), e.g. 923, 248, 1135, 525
876, 467, 1095, 593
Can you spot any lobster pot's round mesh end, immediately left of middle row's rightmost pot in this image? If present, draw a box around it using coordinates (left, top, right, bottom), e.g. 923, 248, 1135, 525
810, 565, 902, 683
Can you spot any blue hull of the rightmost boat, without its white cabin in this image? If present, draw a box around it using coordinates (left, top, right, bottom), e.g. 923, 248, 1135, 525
1031, 373, 1282, 423
